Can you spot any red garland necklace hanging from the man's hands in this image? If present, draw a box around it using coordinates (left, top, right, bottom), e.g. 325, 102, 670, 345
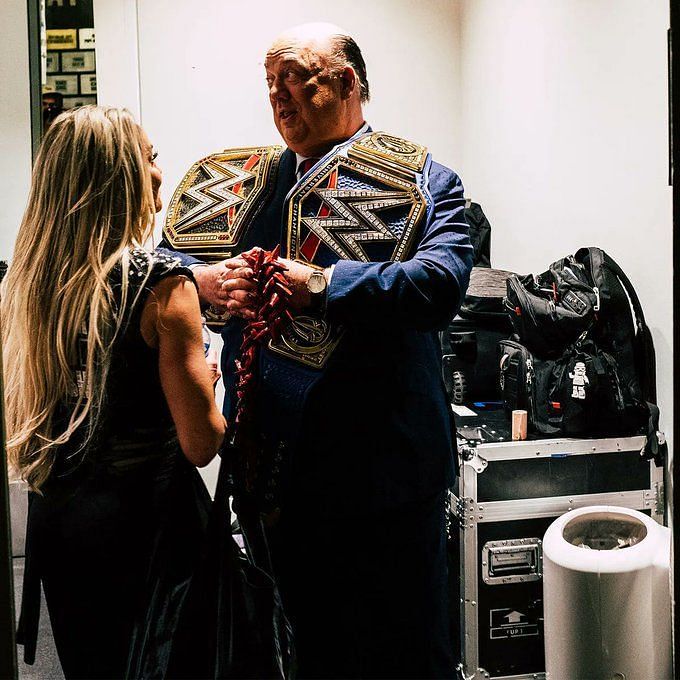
233, 246, 293, 491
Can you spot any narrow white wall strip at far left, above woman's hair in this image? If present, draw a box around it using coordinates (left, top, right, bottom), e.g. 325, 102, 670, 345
0, 0, 31, 260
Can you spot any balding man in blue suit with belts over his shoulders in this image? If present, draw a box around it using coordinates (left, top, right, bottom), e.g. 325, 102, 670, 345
166, 24, 472, 678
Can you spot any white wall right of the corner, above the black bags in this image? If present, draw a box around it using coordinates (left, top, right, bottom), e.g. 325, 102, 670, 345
458, 0, 673, 498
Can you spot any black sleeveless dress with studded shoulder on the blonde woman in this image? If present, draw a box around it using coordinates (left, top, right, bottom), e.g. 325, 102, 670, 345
18, 250, 210, 679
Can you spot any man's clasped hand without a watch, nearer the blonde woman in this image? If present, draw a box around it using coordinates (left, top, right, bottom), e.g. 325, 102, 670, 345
194, 257, 255, 318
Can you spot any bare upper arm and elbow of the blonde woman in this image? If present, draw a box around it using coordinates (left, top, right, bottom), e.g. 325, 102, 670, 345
141, 276, 226, 467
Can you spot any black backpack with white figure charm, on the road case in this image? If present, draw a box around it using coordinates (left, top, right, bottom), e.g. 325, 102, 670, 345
501, 248, 667, 463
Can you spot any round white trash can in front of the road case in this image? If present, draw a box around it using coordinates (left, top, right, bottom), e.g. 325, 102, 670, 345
543, 505, 673, 680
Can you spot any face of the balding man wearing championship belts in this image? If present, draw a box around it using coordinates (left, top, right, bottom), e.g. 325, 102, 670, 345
265, 37, 353, 156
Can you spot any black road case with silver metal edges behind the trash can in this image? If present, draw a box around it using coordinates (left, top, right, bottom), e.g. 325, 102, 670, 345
450, 409, 664, 680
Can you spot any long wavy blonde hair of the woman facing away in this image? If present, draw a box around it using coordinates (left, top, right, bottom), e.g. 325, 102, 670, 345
0, 106, 154, 490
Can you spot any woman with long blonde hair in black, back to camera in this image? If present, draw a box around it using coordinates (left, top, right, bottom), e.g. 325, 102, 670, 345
1, 106, 225, 678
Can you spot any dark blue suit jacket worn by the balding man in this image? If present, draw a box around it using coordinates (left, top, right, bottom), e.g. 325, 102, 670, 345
161, 142, 472, 516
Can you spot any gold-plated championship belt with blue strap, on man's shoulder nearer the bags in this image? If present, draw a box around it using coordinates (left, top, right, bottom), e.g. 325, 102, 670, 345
269, 132, 431, 369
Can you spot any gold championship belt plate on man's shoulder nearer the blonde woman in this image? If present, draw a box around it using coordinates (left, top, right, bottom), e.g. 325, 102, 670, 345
163, 146, 283, 328
